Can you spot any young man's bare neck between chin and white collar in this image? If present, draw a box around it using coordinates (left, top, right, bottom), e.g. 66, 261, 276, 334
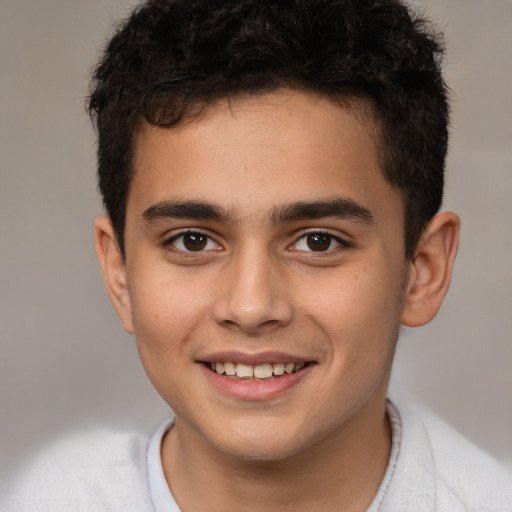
162, 396, 391, 512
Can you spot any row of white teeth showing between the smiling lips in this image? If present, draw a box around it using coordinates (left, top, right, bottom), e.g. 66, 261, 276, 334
204, 361, 313, 381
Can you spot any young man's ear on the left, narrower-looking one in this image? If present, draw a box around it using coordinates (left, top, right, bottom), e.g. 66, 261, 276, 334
94, 215, 133, 334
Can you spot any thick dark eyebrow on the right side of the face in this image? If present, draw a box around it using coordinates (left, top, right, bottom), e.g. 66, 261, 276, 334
270, 197, 373, 226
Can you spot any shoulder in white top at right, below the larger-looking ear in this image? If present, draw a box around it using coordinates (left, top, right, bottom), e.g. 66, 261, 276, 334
388, 407, 512, 512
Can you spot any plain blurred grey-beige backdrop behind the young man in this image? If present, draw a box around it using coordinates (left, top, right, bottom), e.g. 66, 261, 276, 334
0, 0, 512, 480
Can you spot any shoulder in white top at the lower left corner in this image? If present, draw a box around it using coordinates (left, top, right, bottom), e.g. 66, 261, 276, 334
2, 429, 152, 512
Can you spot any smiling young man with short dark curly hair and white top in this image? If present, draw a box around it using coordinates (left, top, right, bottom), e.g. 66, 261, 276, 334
4, 0, 512, 512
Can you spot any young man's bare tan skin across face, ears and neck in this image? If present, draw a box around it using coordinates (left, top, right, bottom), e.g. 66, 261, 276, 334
96, 91, 459, 512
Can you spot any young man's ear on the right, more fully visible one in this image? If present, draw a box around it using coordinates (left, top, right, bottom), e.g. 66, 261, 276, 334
401, 212, 460, 327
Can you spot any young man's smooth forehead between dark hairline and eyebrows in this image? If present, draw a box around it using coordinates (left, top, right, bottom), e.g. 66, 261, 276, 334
127, 91, 401, 224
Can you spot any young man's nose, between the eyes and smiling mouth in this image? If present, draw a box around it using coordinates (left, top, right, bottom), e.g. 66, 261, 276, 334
213, 247, 293, 335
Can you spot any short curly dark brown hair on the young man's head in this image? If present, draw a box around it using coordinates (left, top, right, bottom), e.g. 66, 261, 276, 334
87, 0, 449, 258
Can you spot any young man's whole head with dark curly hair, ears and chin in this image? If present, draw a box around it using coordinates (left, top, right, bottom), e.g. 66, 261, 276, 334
90, 0, 458, 460
